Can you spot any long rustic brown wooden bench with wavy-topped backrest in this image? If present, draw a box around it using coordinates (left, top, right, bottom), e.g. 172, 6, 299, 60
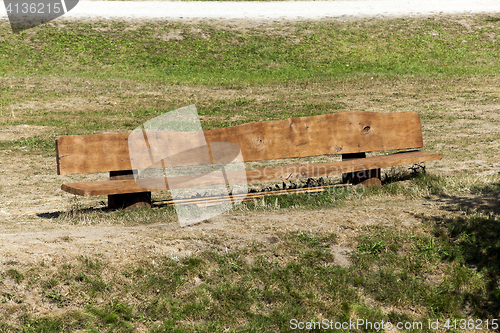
56, 111, 442, 208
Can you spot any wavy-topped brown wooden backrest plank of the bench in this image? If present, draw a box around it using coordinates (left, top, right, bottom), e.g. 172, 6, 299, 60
56, 111, 423, 175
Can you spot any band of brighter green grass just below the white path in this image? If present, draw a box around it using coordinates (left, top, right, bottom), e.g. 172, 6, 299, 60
0, 17, 500, 85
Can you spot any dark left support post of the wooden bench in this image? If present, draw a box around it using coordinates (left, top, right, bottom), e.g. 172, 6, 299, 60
108, 170, 151, 210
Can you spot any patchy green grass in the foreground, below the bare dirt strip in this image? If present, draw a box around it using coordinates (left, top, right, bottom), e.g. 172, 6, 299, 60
1, 216, 500, 332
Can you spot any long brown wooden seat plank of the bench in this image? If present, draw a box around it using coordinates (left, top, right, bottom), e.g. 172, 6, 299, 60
61, 151, 442, 196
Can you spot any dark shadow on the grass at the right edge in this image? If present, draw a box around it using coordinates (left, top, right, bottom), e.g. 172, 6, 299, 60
418, 182, 500, 318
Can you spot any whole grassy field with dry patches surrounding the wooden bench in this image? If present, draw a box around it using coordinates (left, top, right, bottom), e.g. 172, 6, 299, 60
0, 15, 500, 332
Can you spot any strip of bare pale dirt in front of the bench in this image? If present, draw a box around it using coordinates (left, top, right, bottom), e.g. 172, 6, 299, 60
0, 197, 458, 266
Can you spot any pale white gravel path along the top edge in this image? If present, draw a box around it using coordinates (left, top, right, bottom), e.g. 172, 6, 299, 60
0, 0, 500, 20
